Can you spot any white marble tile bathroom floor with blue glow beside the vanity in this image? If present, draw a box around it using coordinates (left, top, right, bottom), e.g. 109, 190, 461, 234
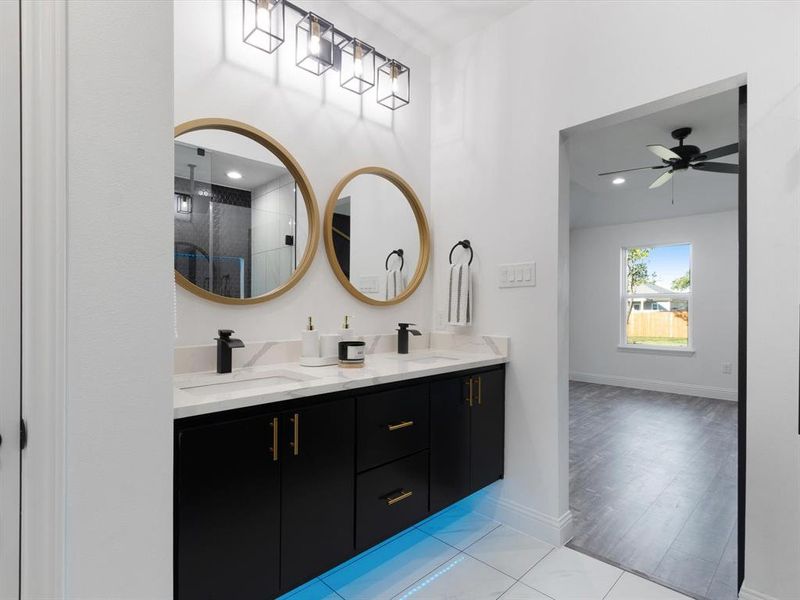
281, 506, 687, 600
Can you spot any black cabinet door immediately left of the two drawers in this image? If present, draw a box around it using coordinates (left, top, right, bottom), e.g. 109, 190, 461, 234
281, 398, 355, 591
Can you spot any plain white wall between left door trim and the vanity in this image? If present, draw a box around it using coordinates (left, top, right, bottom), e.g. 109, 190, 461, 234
64, 0, 173, 600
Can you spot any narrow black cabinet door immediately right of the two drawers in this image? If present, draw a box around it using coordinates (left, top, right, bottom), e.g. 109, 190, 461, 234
430, 377, 471, 513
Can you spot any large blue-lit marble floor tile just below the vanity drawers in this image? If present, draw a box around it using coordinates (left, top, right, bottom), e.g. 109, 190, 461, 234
324, 529, 458, 600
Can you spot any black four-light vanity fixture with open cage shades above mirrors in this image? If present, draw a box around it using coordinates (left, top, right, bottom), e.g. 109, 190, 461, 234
242, 0, 411, 110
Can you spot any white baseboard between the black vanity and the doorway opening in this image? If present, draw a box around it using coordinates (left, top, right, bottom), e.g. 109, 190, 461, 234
467, 494, 573, 546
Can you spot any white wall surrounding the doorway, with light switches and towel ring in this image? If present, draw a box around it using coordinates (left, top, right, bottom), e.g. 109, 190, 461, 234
431, 1, 800, 598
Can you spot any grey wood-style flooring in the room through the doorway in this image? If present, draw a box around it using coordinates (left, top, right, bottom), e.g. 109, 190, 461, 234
569, 382, 737, 600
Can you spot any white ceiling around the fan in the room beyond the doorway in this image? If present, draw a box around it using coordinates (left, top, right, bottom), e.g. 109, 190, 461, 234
567, 90, 739, 227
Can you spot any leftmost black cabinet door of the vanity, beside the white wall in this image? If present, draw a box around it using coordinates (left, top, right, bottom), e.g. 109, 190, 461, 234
175, 417, 280, 600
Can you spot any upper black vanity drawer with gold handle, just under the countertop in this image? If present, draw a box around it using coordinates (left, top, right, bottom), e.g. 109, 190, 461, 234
356, 384, 429, 471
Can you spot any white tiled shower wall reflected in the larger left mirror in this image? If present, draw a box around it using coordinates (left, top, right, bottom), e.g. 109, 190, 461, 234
251, 174, 297, 296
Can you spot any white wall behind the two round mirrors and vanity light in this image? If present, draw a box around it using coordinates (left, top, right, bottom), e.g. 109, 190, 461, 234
174, 0, 431, 346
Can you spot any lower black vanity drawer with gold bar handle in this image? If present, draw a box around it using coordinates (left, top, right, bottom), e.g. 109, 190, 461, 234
356, 452, 428, 550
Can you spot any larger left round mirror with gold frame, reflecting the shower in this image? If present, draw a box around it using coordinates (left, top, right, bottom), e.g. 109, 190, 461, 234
173, 118, 319, 304
